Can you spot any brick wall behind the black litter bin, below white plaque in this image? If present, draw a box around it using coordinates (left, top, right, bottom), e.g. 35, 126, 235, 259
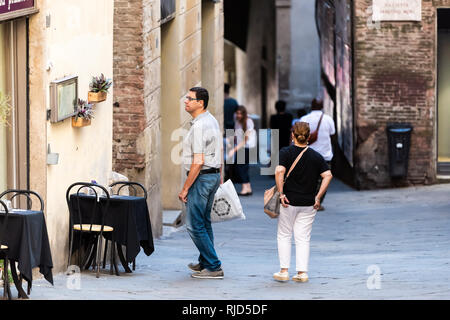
353, 0, 450, 189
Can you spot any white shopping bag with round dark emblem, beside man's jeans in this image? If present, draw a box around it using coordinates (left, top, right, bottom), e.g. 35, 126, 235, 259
211, 180, 245, 222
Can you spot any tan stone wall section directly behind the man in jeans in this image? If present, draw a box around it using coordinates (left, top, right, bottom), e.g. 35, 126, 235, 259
161, 0, 202, 210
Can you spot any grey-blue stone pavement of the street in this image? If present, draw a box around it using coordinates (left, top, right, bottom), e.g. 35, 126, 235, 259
23, 167, 450, 300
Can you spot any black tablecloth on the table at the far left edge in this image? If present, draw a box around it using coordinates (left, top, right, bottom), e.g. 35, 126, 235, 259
0, 210, 53, 284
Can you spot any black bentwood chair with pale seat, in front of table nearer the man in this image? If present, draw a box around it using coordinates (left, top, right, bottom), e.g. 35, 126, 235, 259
66, 182, 118, 278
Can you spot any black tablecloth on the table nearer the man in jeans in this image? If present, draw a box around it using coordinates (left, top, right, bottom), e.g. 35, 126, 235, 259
70, 194, 154, 262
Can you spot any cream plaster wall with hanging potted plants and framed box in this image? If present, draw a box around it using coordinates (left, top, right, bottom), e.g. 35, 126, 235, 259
28, 0, 114, 272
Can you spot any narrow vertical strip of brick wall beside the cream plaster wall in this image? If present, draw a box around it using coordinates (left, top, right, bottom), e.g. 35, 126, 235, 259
113, 0, 146, 175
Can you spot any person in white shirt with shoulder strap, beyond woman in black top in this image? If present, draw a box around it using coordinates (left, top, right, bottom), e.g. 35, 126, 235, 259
300, 99, 336, 211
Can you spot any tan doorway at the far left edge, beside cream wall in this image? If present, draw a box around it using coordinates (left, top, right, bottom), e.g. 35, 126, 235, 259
0, 19, 28, 191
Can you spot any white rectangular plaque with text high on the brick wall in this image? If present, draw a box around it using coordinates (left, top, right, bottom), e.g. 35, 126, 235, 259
372, 0, 422, 21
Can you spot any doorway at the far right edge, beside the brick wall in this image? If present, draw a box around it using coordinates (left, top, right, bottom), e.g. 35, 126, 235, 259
437, 9, 450, 175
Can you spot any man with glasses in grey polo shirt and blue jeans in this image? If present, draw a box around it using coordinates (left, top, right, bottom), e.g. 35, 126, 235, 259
178, 87, 224, 279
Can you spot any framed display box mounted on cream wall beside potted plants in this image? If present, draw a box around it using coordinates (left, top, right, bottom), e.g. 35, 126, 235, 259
50, 76, 78, 123
